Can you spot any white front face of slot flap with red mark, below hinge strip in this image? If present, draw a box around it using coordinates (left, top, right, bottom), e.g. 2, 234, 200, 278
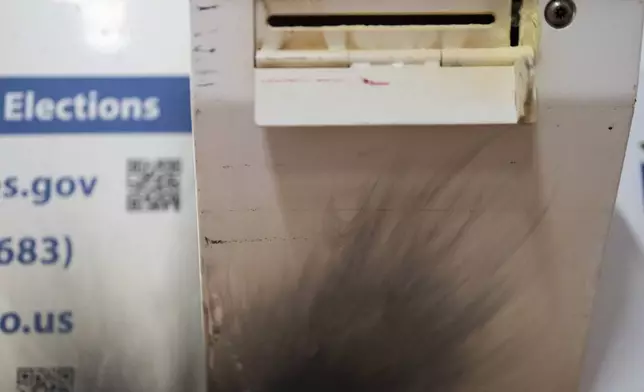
255, 64, 525, 127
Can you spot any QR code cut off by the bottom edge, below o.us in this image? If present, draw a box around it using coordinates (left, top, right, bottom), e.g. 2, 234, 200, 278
16, 367, 74, 392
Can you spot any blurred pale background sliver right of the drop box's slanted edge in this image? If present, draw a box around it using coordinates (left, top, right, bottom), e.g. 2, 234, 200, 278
581, 37, 644, 392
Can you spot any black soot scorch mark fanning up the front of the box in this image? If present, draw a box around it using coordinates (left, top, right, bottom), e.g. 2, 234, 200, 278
206, 136, 542, 392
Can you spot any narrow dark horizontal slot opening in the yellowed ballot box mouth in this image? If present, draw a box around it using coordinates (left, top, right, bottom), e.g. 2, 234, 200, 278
266, 13, 496, 28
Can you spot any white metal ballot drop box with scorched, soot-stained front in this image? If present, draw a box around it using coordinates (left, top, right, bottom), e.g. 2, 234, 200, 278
193, 0, 643, 392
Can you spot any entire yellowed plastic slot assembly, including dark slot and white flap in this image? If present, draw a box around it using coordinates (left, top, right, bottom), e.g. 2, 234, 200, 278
254, 0, 539, 127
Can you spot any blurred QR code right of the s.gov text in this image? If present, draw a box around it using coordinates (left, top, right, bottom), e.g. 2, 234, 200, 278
126, 158, 182, 212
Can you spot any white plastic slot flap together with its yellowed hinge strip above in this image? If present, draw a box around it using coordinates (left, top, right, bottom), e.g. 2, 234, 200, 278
255, 47, 534, 127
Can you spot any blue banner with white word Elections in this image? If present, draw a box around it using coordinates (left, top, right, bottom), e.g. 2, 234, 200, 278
0, 76, 192, 134
